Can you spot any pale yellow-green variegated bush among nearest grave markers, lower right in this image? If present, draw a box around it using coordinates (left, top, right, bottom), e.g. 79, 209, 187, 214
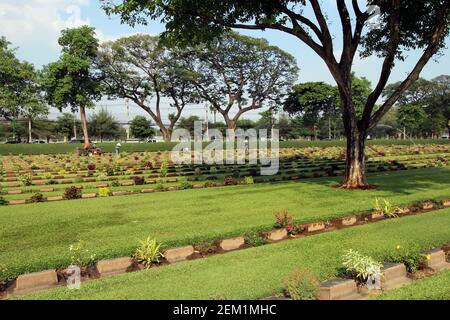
342, 249, 383, 282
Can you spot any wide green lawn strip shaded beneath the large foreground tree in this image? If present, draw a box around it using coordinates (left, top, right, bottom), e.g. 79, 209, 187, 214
0, 168, 450, 275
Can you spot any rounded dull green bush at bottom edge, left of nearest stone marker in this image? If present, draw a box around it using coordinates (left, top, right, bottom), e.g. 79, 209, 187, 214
284, 270, 320, 300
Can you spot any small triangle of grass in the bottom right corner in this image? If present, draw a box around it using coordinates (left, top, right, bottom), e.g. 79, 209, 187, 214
376, 270, 450, 300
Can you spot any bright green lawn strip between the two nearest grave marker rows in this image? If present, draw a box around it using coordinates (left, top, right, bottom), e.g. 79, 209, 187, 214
24, 209, 450, 299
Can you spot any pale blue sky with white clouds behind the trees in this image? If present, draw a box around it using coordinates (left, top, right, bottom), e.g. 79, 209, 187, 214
0, 0, 450, 122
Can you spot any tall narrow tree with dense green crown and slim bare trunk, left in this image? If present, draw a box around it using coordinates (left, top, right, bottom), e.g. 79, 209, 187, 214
42, 26, 101, 148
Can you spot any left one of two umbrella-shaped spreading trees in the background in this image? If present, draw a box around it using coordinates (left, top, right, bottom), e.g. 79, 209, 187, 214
97, 34, 198, 142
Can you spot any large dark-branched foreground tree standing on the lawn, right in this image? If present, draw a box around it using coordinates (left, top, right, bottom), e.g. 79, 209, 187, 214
104, 0, 450, 188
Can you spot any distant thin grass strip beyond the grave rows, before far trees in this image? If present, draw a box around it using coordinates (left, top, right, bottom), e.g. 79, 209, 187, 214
0, 139, 450, 155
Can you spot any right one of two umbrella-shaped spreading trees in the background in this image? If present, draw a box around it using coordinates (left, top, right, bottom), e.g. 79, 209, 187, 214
178, 32, 298, 130
